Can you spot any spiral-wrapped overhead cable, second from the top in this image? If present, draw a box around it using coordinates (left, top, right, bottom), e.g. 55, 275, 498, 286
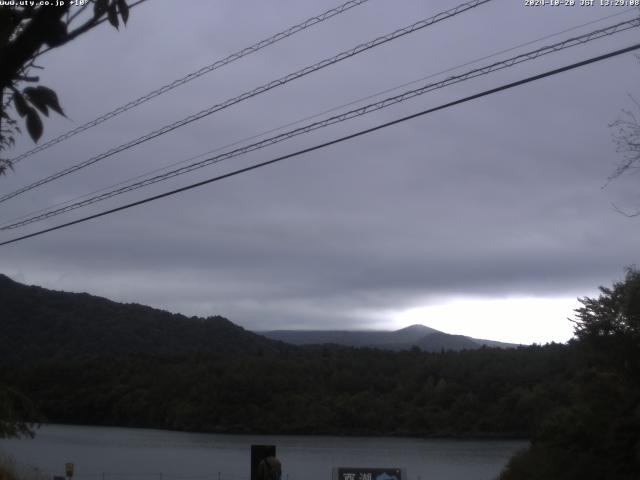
0, 0, 492, 202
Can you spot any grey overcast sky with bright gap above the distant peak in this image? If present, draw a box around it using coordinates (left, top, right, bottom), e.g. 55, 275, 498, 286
0, 0, 640, 343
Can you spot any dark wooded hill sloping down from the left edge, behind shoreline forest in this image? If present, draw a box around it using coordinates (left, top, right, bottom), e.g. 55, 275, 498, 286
0, 274, 292, 363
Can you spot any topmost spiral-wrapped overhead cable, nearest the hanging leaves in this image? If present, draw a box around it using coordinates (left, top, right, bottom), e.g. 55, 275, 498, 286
11, 0, 369, 164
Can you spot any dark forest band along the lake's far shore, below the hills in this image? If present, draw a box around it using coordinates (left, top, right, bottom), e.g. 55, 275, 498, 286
0, 345, 575, 437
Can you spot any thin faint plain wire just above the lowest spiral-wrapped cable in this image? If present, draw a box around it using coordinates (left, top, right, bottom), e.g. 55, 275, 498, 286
0, 3, 635, 230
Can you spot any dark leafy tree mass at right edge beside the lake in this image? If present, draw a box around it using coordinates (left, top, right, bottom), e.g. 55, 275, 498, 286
501, 268, 640, 480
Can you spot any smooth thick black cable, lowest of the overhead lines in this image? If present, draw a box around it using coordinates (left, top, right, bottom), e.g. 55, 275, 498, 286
0, 43, 640, 246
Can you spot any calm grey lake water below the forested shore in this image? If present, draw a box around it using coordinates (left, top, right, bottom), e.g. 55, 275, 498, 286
0, 425, 527, 480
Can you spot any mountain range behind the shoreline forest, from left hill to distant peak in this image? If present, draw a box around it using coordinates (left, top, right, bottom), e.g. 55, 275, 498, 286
0, 274, 513, 363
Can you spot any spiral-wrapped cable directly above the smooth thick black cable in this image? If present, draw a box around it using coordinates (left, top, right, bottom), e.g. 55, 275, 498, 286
0, 18, 640, 230
